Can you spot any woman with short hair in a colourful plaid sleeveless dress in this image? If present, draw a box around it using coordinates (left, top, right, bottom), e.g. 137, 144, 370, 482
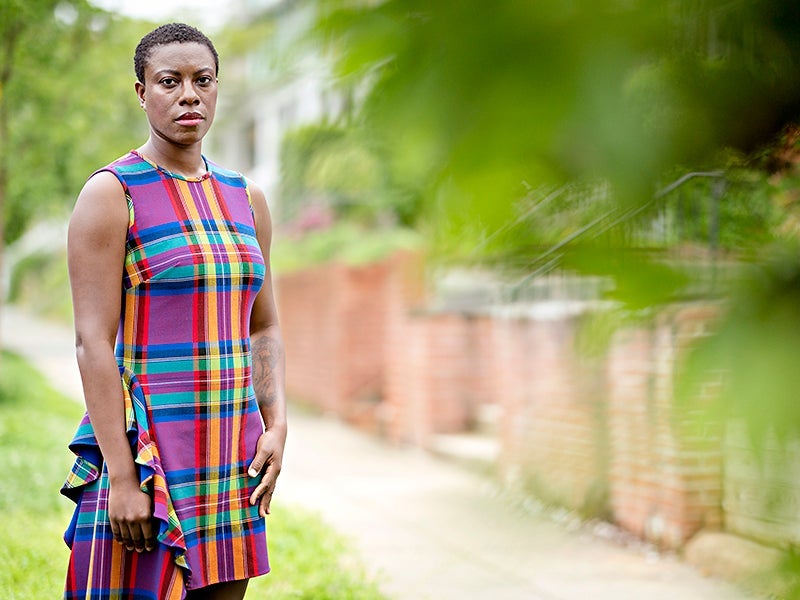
62, 23, 286, 600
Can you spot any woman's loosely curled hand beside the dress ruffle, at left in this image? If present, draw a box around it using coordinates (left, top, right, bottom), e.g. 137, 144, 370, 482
108, 479, 156, 552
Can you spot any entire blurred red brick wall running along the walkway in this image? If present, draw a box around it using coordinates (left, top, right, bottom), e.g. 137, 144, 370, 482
276, 255, 722, 547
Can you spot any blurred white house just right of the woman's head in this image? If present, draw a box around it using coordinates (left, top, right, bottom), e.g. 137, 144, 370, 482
209, 0, 343, 212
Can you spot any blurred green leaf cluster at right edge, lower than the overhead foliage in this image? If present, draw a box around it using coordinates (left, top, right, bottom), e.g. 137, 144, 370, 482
682, 248, 800, 440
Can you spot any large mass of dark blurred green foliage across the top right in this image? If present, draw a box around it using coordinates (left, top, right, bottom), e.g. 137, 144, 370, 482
315, 0, 800, 270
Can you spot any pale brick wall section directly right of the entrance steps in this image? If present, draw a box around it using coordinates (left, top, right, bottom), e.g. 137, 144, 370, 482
495, 318, 607, 513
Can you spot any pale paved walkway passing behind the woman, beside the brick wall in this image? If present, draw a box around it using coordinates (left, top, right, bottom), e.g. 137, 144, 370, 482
0, 309, 747, 600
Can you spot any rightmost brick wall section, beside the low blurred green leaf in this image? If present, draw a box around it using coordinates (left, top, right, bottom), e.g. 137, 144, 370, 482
608, 308, 722, 547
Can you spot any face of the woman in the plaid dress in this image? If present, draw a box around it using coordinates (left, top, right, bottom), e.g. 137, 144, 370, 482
136, 42, 217, 147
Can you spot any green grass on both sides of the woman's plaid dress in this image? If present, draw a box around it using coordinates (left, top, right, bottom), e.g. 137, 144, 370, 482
0, 353, 383, 600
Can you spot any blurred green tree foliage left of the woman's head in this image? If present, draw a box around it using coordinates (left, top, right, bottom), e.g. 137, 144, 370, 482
0, 0, 147, 243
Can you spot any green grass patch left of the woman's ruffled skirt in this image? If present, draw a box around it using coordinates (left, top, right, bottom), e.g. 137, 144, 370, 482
0, 352, 82, 600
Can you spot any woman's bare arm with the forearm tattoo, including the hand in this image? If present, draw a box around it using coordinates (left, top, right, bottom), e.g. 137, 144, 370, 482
248, 185, 287, 516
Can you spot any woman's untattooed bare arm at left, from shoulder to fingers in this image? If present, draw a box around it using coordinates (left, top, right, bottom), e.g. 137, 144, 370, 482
67, 173, 154, 551
